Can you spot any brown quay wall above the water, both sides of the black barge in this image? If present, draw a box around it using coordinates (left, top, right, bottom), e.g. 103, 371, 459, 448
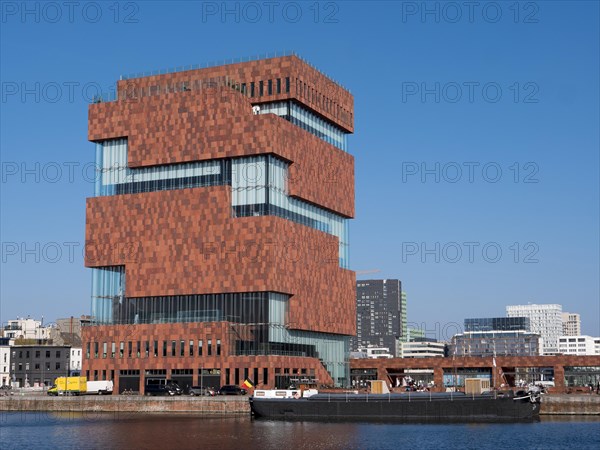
0, 394, 600, 415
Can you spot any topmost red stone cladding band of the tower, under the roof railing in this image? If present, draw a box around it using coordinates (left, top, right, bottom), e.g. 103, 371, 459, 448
117, 56, 354, 133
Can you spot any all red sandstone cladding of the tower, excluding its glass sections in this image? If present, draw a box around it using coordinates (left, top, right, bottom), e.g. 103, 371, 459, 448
83, 57, 356, 392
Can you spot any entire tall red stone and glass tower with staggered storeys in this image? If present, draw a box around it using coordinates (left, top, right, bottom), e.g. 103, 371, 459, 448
83, 56, 356, 392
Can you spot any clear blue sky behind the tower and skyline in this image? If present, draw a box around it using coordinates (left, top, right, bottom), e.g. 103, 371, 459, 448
0, 2, 600, 338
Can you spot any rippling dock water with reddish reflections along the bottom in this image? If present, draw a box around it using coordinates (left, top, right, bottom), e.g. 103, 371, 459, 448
0, 412, 600, 450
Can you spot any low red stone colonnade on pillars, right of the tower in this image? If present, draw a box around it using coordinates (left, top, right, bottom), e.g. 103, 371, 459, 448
350, 355, 600, 392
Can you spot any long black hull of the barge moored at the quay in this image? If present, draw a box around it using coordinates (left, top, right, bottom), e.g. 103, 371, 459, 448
250, 394, 540, 423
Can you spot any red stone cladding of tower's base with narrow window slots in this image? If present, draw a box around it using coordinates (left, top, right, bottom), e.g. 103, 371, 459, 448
82, 322, 333, 392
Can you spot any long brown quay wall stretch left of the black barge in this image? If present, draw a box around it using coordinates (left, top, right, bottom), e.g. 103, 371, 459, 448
0, 395, 250, 415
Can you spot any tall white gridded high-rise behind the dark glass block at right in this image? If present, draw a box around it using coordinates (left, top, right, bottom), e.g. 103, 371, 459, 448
506, 304, 563, 355
